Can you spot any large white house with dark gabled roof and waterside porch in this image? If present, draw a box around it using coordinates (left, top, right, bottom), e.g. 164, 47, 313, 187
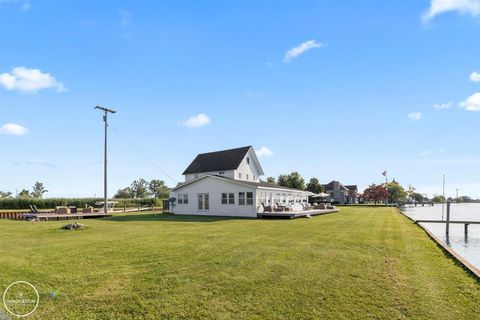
170, 146, 310, 217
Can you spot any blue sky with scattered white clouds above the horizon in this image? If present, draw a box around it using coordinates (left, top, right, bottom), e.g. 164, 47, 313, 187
0, 0, 480, 198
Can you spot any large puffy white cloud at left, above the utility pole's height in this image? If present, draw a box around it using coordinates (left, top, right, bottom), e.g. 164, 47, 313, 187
0, 67, 66, 93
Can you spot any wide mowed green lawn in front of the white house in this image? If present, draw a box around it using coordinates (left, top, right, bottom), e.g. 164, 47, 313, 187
0, 207, 480, 319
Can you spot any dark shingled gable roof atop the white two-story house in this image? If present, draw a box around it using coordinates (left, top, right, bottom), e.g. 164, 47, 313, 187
183, 146, 252, 174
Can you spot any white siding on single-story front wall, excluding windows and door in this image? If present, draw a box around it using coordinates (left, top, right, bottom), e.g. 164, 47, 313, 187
170, 177, 257, 218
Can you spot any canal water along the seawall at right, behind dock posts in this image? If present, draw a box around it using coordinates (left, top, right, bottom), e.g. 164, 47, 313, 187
402, 203, 480, 269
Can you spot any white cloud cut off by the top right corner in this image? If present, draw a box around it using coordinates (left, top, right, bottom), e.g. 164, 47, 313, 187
422, 0, 480, 22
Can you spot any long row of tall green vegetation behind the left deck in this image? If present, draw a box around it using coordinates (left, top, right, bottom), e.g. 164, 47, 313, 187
0, 198, 163, 210
